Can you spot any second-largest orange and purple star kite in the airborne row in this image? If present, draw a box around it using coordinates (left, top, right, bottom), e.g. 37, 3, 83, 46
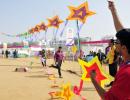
48, 16, 63, 28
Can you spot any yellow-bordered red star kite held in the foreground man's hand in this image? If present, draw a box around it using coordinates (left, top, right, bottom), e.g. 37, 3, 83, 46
78, 56, 114, 87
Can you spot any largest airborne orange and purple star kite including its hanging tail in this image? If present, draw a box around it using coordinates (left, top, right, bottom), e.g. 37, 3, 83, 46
67, 2, 95, 56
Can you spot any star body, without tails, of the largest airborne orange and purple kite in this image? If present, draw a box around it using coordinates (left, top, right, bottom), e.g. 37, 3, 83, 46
67, 2, 95, 23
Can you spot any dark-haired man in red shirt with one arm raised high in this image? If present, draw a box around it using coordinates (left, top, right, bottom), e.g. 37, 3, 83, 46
90, 1, 130, 100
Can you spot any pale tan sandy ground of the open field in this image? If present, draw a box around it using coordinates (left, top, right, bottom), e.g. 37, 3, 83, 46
0, 58, 106, 100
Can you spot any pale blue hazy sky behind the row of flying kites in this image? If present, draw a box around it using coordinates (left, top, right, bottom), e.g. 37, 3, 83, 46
0, 0, 130, 42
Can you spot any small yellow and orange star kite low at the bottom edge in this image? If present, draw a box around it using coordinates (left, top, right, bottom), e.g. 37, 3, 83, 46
62, 84, 73, 100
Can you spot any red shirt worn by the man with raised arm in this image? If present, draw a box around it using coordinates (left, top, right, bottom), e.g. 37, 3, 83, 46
104, 64, 130, 100
